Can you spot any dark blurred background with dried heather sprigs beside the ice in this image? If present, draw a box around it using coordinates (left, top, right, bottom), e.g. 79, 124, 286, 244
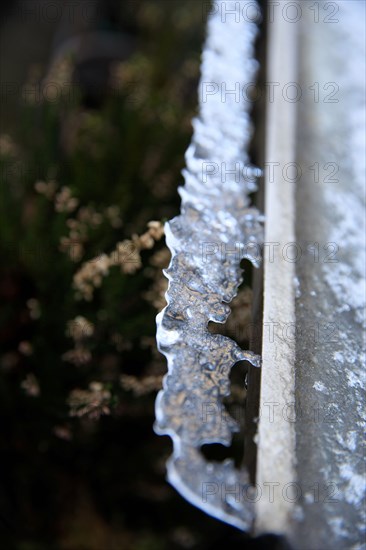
0, 0, 279, 550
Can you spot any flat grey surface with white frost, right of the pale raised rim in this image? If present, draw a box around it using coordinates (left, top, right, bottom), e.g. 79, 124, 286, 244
294, 0, 366, 550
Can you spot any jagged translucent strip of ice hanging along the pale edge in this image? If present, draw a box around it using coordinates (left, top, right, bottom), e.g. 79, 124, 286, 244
155, 1, 262, 530
